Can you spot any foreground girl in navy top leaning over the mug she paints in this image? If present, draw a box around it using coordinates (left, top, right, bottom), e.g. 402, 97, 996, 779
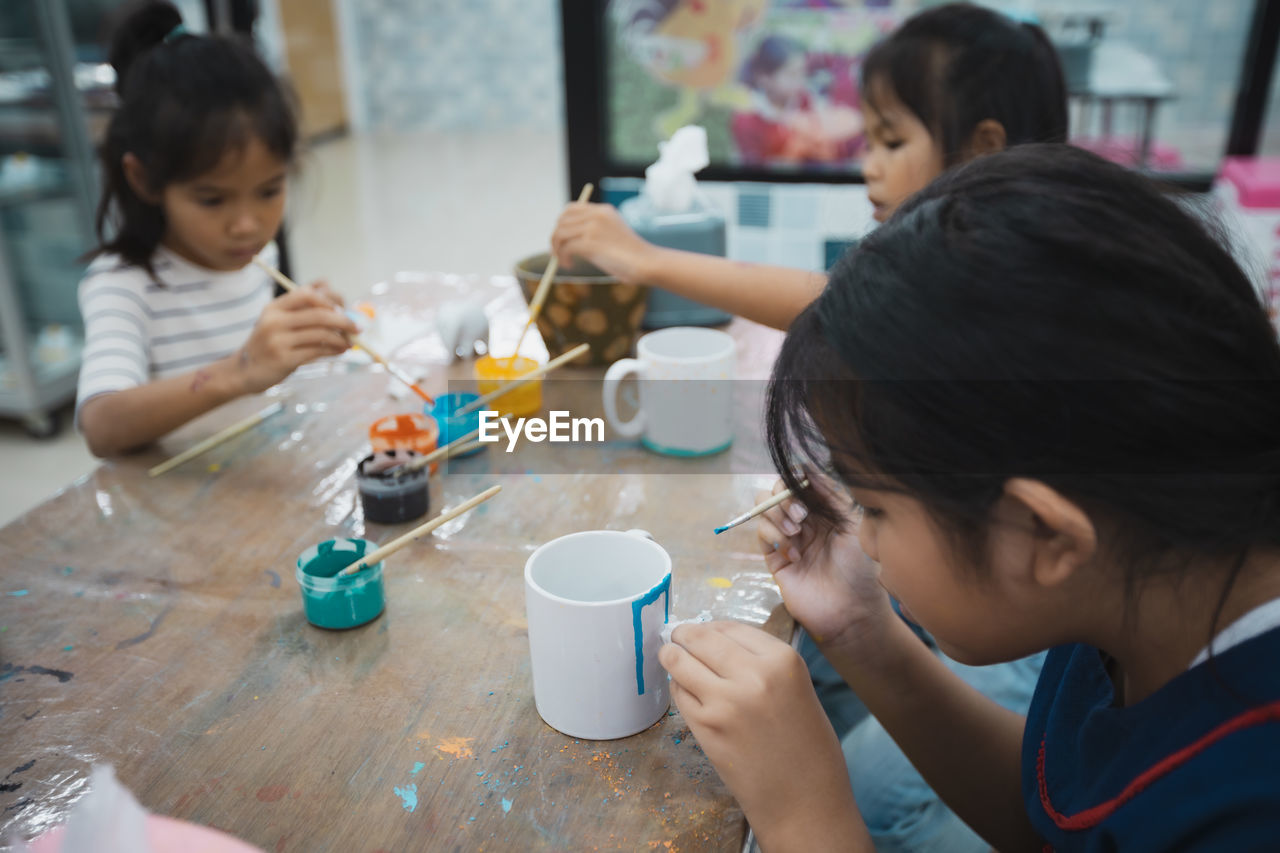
662, 146, 1280, 852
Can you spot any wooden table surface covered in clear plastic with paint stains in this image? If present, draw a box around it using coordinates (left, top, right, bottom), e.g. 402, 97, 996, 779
0, 275, 790, 853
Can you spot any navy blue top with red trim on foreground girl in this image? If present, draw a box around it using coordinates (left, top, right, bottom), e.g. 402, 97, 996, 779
1023, 629, 1280, 853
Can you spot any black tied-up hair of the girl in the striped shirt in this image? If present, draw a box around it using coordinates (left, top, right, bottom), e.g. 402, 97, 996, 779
92, 0, 298, 272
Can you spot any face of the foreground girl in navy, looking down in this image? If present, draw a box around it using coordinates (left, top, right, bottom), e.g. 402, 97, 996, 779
854, 488, 1044, 666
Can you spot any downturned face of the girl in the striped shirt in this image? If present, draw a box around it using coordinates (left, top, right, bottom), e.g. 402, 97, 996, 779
160, 137, 288, 272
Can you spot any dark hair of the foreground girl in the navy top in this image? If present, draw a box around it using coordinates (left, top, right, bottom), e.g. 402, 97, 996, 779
767, 145, 1280, 591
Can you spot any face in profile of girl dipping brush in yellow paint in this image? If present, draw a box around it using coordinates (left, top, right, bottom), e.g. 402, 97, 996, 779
863, 89, 943, 222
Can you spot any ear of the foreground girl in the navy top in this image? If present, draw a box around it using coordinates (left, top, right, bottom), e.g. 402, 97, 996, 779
1005, 476, 1098, 587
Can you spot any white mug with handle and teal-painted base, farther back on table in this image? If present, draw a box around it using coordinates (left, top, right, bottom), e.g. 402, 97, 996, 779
604, 327, 736, 456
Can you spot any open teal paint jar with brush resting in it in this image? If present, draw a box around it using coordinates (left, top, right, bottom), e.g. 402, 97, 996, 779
294, 539, 387, 629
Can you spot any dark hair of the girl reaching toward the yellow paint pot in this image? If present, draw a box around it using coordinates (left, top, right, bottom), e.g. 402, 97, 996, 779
861, 3, 1068, 167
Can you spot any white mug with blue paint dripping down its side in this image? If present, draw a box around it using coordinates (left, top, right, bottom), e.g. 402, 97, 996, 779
525, 530, 671, 740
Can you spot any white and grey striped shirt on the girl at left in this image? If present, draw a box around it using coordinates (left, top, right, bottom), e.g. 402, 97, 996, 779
76, 243, 276, 420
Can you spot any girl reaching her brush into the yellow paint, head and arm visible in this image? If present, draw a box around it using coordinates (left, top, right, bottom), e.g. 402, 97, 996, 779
552, 3, 1066, 329
